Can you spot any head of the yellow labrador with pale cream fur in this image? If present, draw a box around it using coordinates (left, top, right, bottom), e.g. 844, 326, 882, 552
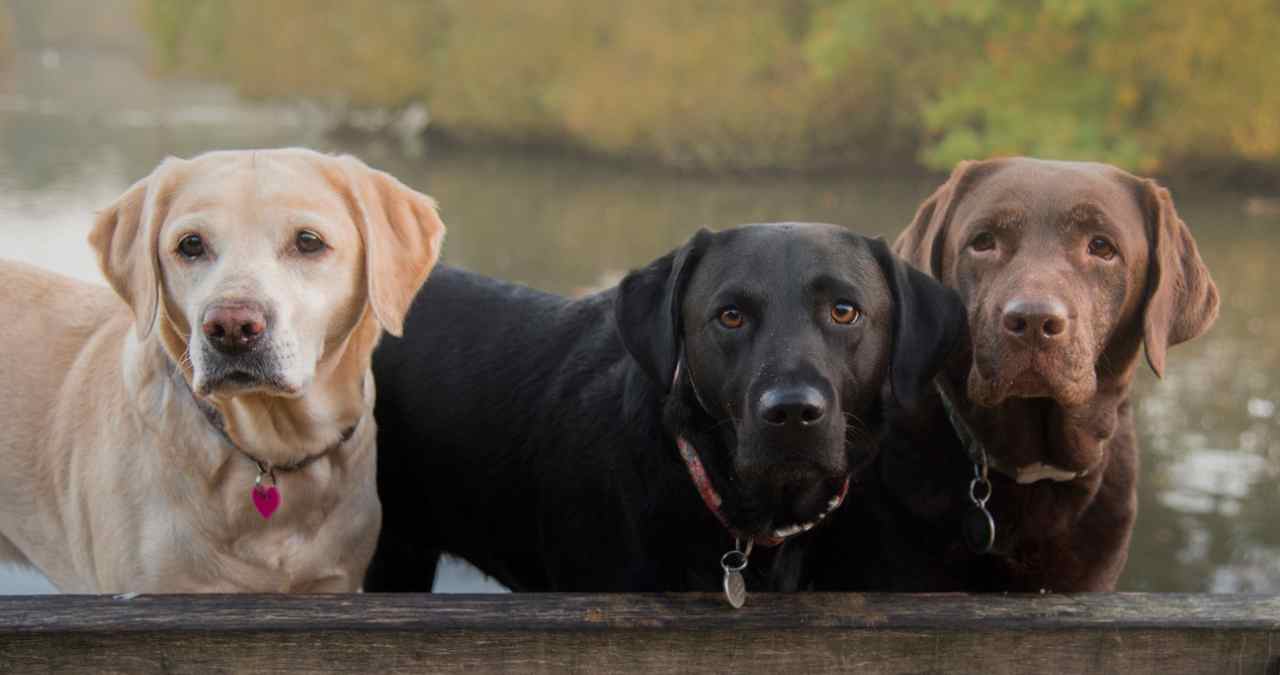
90, 149, 444, 400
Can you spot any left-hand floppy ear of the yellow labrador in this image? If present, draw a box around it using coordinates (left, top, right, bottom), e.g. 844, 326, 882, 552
88, 158, 182, 339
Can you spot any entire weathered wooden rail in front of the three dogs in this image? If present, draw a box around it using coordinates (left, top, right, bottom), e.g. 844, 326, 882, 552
0, 593, 1280, 675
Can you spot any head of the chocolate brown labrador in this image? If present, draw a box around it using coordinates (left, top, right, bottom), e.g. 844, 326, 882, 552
895, 158, 1219, 482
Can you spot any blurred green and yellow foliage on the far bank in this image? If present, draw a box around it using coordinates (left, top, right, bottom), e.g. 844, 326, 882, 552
140, 0, 1280, 170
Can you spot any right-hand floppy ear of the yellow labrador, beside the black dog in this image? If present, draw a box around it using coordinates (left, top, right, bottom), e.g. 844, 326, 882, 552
338, 156, 444, 337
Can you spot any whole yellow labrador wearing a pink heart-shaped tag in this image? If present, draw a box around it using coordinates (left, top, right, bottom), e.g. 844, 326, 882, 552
0, 149, 444, 593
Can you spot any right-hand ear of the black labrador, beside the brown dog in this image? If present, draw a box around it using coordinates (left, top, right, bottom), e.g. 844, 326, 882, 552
868, 240, 969, 409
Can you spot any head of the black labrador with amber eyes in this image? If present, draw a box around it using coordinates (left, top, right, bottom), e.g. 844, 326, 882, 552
617, 223, 965, 539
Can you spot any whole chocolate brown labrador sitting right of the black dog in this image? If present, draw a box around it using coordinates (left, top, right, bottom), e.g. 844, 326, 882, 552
818, 159, 1219, 592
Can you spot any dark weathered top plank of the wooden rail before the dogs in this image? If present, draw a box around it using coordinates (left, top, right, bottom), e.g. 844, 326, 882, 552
0, 593, 1280, 635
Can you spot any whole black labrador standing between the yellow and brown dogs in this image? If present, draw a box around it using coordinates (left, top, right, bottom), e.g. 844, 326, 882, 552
366, 224, 964, 590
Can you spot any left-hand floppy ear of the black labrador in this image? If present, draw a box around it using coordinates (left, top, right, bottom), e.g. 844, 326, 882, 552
613, 228, 712, 392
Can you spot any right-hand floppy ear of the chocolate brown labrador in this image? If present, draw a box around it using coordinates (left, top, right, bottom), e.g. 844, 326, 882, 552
1140, 178, 1219, 377
